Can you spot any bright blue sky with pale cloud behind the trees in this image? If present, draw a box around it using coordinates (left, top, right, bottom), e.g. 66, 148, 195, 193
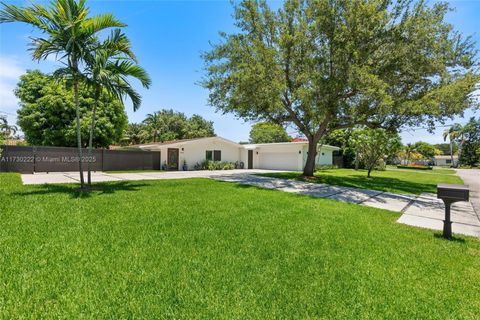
0, 0, 480, 143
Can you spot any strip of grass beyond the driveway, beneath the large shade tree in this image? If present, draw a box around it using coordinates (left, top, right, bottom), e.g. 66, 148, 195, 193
259, 169, 463, 194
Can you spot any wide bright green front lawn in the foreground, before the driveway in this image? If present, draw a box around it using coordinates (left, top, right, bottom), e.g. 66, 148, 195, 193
0, 174, 480, 319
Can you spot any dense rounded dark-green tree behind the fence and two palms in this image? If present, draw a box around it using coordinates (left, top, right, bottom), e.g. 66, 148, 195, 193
15, 71, 128, 147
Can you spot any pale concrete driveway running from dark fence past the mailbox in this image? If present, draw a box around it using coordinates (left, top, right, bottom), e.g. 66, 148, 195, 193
22, 169, 480, 237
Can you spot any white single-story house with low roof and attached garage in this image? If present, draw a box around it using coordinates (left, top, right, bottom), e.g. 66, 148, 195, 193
137, 137, 340, 171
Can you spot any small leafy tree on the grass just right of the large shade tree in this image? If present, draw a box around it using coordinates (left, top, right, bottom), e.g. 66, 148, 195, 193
351, 128, 401, 177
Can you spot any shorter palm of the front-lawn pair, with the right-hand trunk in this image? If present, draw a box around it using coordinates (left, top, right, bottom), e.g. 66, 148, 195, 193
86, 29, 151, 186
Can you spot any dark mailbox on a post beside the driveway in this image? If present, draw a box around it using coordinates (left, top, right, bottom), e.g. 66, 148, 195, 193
437, 184, 469, 239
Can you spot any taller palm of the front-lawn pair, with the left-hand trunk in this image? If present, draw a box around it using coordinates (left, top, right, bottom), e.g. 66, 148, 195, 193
0, 0, 125, 189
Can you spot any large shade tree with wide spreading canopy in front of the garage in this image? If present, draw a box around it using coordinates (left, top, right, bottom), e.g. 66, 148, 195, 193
202, 0, 478, 176
